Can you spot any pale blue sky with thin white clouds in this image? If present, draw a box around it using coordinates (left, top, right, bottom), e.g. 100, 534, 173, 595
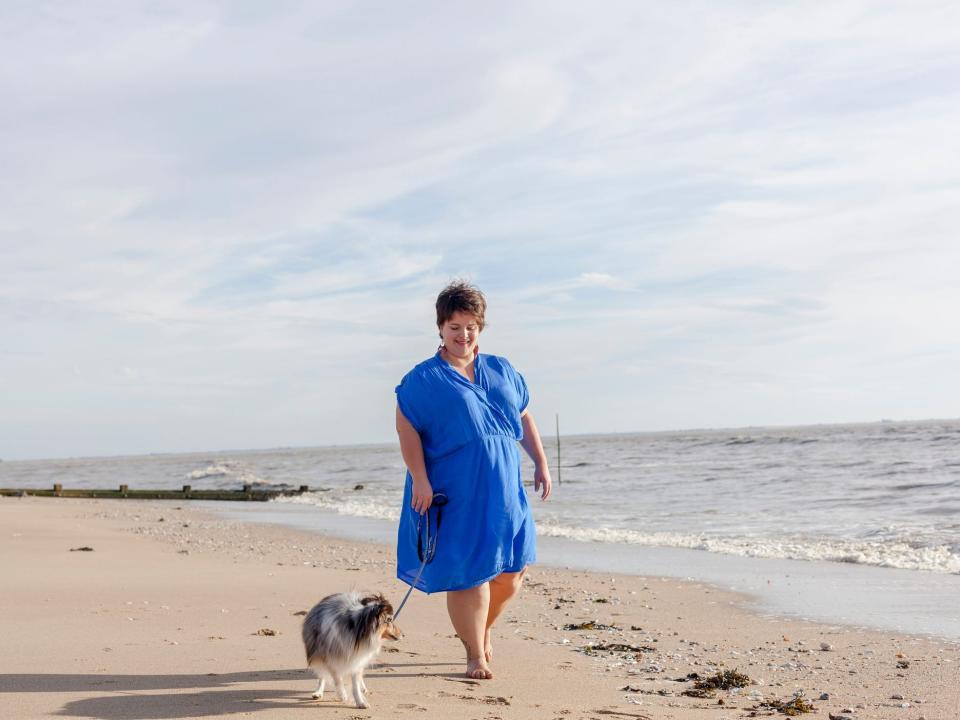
0, 0, 960, 459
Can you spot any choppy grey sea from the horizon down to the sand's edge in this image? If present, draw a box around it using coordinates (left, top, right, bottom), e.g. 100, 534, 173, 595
0, 420, 960, 641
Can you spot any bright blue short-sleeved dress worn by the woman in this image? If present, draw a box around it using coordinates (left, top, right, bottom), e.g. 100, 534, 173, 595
397, 352, 536, 593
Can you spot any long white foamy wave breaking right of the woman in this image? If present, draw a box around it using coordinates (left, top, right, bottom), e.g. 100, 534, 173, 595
537, 522, 960, 574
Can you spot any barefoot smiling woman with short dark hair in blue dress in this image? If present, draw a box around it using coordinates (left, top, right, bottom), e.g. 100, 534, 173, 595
397, 282, 552, 680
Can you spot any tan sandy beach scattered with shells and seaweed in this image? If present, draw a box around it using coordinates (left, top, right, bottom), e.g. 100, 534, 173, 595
0, 498, 960, 720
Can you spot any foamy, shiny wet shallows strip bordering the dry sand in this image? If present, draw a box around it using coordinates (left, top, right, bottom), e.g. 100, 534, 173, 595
210, 503, 960, 643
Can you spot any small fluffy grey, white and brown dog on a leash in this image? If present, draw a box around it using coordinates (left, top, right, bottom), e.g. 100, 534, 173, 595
303, 592, 403, 708
